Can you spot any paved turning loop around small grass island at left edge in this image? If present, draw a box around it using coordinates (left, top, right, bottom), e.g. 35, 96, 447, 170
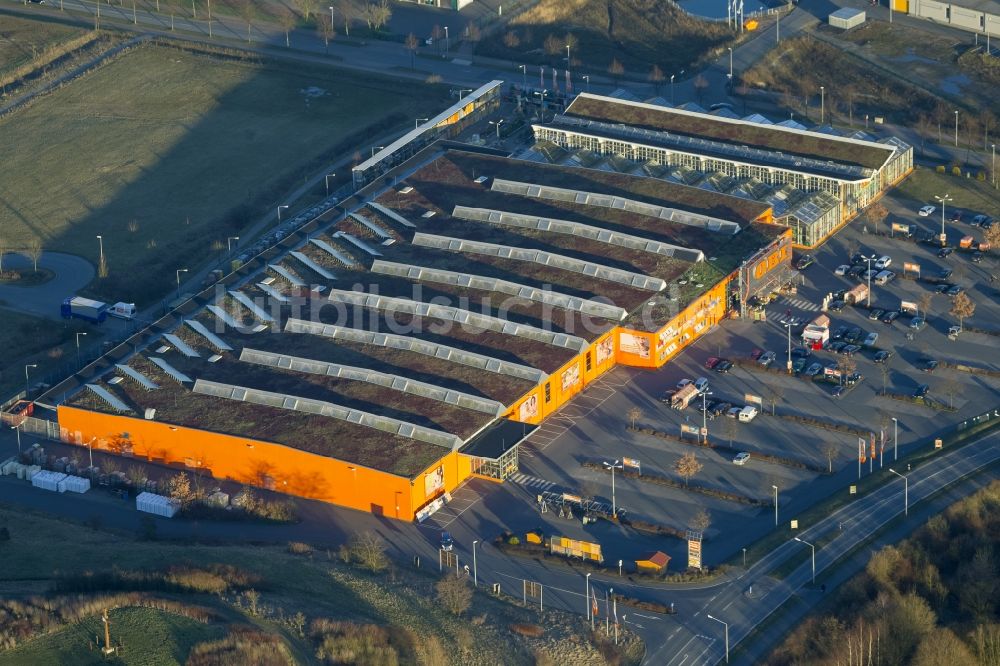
0, 252, 94, 319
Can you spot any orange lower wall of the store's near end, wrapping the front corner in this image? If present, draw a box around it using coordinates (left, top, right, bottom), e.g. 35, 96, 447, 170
59, 406, 472, 520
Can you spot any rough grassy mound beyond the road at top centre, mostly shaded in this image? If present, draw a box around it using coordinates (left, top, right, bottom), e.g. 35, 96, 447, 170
479, 0, 733, 76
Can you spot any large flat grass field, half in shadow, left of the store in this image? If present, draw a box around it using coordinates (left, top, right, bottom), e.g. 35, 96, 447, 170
0, 39, 444, 304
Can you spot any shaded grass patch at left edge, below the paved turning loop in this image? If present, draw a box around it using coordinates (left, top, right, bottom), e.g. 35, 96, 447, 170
0, 310, 93, 400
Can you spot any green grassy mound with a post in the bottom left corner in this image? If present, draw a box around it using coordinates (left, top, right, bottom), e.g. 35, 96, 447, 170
0, 608, 225, 666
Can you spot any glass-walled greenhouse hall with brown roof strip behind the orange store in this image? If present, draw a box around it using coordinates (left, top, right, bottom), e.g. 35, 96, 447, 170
533, 93, 913, 247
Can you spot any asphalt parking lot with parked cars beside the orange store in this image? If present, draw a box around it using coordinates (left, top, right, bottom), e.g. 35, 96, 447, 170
513, 189, 1000, 569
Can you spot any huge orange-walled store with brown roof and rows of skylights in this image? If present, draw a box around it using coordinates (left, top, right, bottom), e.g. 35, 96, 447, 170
51, 148, 791, 520
